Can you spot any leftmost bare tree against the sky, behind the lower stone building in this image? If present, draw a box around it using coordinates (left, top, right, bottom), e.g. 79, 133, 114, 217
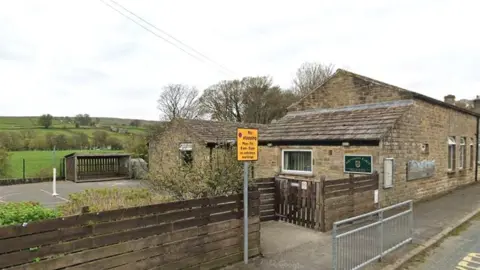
157, 84, 200, 120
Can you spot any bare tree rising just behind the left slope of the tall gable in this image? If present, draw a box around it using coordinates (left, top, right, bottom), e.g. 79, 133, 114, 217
293, 62, 335, 97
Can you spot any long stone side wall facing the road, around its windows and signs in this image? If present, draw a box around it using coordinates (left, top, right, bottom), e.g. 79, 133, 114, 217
380, 100, 476, 205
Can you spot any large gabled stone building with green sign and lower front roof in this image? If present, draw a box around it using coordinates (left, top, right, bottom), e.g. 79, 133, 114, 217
255, 69, 480, 205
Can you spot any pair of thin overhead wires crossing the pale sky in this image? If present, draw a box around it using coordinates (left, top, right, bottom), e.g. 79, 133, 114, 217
100, 0, 235, 75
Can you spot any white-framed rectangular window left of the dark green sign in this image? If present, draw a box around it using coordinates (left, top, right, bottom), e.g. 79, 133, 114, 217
282, 149, 313, 174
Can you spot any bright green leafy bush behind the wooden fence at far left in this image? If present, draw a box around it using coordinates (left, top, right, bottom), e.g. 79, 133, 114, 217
0, 202, 59, 226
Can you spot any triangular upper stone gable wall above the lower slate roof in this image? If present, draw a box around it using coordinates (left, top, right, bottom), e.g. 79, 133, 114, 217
289, 71, 412, 111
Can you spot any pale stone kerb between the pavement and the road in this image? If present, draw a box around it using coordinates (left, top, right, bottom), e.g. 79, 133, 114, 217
382, 205, 480, 270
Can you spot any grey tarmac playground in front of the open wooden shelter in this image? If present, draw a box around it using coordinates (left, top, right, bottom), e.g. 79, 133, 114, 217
0, 180, 141, 208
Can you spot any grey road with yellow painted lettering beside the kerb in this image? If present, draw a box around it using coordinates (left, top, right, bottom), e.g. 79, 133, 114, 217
403, 216, 480, 270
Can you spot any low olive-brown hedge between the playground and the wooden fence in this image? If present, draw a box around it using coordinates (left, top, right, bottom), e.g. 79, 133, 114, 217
59, 188, 171, 216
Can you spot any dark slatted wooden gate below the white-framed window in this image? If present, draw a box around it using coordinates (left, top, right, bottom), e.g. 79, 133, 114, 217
275, 177, 321, 229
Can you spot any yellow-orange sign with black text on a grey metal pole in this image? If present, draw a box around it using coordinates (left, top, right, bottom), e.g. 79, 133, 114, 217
237, 128, 258, 161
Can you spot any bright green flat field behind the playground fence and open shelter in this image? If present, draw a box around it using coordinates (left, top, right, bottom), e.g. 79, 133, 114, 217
8, 150, 125, 178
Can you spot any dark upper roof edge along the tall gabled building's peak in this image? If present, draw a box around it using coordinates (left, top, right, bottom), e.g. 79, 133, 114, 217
290, 68, 480, 117
